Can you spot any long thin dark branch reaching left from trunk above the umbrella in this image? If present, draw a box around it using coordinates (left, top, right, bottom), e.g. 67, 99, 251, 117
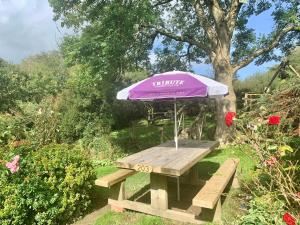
142, 24, 211, 54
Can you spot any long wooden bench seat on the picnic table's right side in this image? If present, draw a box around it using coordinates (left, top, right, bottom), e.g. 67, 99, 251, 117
193, 159, 239, 209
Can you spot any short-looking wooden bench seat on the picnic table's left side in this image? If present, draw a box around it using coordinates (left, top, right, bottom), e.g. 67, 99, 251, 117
95, 169, 136, 187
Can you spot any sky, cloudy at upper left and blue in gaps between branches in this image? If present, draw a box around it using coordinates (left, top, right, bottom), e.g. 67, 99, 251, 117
0, 0, 275, 79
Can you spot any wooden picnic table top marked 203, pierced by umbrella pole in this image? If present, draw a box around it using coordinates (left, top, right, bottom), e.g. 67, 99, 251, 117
116, 140, 219, 176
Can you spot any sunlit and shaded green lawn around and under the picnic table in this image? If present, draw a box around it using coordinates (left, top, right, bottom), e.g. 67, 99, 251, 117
90, 118, 256, 225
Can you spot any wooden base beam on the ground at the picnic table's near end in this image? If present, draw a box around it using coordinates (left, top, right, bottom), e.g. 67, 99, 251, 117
108, 199, 207, 224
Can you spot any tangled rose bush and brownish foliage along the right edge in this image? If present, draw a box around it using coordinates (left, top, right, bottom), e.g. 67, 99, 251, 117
235, 77, 300, 211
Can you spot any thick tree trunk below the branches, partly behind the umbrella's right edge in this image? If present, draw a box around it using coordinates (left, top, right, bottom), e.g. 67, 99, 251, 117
214, 60, 236, 143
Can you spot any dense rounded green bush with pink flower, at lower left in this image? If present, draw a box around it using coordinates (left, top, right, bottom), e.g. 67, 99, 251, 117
0, 145, 95, 225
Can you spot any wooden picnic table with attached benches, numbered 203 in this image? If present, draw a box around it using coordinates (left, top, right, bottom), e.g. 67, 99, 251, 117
96, 140, 236, 224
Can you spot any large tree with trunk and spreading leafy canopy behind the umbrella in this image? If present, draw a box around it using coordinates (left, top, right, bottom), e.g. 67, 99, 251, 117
49, 0, 300, 139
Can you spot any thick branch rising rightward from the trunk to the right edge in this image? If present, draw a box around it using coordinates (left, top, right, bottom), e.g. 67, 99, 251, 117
233, 25, 300, 71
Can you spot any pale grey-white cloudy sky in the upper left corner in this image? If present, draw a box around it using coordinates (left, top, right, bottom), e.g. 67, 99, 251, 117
0, 0, 71, 63
